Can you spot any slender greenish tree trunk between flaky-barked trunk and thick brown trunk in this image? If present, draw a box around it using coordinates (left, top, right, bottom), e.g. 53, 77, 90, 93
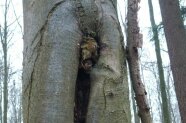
148, 0, 170, 123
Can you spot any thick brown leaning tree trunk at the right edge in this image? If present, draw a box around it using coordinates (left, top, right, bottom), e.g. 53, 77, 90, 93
159, 0, 186, 123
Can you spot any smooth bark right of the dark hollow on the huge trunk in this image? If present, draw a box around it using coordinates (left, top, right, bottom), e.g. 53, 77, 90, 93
87, 0, 131, 123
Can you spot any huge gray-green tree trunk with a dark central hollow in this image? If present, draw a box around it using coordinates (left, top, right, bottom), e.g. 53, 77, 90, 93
23, 0, 130, 123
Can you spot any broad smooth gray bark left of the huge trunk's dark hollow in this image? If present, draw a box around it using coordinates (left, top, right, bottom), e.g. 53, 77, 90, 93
23, 0, 81, 123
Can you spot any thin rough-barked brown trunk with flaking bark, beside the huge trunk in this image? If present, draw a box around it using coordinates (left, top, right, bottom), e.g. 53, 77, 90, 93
127, 0, 152, 123
